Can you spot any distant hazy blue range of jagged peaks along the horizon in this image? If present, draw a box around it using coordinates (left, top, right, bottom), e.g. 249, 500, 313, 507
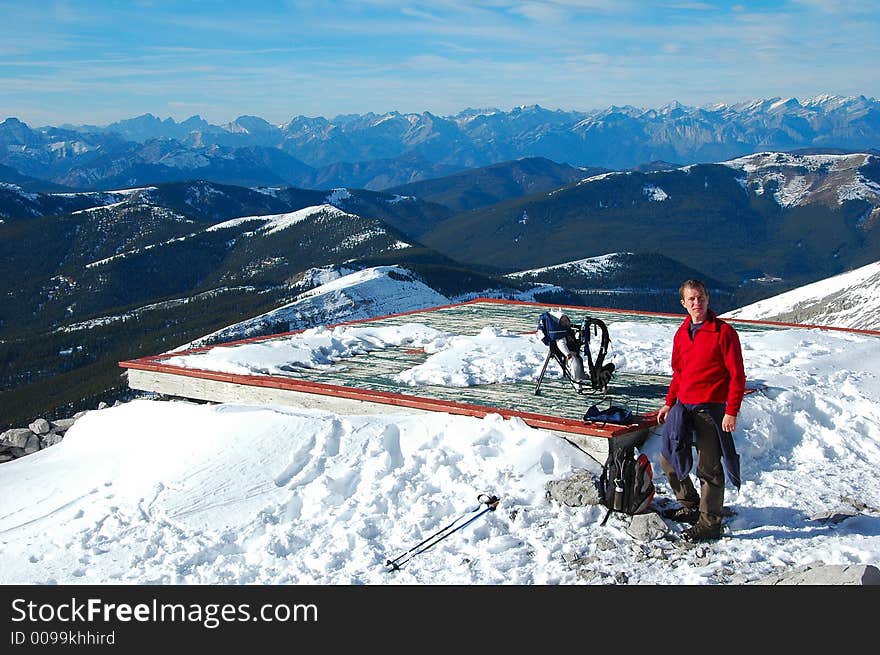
0, 95, 880, 190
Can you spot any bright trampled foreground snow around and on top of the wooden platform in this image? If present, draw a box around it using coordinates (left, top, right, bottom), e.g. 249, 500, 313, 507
0, 292, 880, 585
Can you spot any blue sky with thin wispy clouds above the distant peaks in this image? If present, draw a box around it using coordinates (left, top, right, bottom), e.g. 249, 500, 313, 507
0, 0, 880, 127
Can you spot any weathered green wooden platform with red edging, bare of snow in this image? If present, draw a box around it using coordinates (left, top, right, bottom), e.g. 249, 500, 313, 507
120, 299, 792, 462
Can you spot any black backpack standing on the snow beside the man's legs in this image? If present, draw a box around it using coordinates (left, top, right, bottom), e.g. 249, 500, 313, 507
599, 435, 655, 525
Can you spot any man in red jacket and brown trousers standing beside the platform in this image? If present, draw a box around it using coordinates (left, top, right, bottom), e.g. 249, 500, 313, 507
657, 280, 746, 542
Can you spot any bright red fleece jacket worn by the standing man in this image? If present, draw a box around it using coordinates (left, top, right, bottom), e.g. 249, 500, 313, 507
666, 310, 746, 416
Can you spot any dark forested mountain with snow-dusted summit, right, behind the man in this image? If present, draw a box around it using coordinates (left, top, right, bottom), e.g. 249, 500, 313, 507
421, 153, 880, 286
